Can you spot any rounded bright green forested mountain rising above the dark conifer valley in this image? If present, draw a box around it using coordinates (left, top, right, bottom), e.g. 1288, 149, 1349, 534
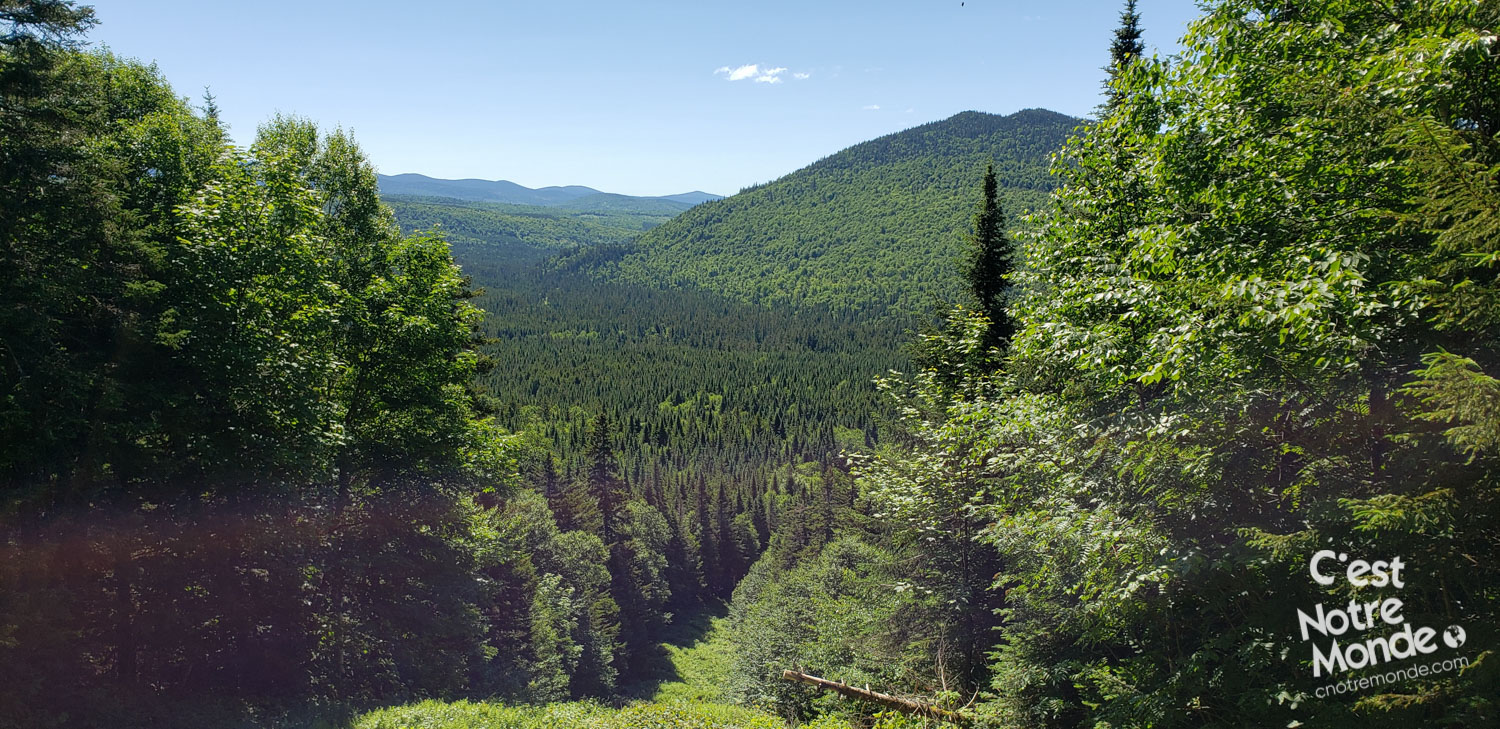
570, 110, 1082, 315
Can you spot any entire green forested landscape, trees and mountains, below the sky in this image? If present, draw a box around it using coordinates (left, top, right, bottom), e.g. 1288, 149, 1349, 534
0, 0, 1500, 729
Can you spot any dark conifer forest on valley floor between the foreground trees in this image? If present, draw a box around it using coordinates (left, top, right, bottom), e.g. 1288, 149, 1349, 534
455, 246, 906, 609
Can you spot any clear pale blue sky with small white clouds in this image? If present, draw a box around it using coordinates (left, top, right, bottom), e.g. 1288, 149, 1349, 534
90, 0, 1197, 195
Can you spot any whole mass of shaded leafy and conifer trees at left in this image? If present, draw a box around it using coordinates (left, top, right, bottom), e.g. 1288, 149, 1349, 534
0, 15, 528, 726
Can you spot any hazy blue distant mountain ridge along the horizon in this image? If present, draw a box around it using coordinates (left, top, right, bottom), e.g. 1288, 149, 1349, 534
375, 173, 720, 210
